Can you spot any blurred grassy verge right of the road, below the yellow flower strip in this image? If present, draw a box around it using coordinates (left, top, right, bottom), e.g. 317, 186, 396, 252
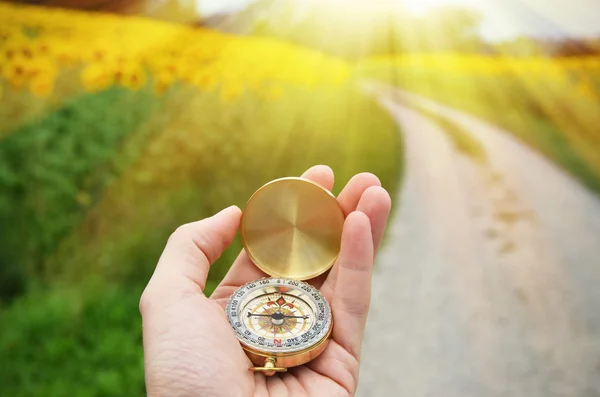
360, 64, 600, 192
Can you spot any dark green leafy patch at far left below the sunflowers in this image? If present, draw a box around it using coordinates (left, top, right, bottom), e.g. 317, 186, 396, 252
0, 88, 162, 299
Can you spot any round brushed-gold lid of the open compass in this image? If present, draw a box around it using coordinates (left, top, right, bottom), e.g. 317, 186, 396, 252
240, 177, 344, 280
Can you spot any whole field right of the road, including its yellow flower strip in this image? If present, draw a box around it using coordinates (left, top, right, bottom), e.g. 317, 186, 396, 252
357, 54, 600, 192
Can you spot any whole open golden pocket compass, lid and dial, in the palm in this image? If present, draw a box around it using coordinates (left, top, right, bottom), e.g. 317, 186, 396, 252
225, 178, 344, 375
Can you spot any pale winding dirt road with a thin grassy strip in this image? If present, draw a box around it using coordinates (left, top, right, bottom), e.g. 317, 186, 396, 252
357, 85, 600, 397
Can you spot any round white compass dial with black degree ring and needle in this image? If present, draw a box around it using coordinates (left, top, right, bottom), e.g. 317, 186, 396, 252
226, 278, 331, 353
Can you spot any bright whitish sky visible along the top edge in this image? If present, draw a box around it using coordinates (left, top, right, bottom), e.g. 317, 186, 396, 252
198, 0, 600, 41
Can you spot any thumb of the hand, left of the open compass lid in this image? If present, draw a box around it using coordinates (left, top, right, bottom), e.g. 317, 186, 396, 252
147, 206, 241, 293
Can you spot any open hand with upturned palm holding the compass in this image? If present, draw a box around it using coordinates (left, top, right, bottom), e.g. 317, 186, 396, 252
140, 166, 391, 397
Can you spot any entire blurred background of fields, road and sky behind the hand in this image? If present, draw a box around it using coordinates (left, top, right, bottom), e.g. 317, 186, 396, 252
0, 0, 600, 397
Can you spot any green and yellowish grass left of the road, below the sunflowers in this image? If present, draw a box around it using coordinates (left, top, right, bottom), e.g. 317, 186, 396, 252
0, 79, 402, 396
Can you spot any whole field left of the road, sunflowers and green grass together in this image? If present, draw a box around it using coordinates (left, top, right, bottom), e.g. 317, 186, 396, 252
0, 4, 402, 396
